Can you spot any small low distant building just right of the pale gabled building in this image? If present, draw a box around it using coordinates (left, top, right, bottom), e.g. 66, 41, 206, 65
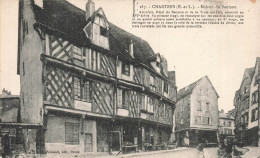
219, 109, 235, 142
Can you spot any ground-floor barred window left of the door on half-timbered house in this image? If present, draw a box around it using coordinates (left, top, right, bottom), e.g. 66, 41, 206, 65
65, 122, 79, 144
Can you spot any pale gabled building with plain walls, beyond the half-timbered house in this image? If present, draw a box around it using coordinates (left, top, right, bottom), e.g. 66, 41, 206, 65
174, 76, 219, 146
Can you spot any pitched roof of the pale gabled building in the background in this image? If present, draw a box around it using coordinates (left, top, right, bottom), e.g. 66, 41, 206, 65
177, 76, 219, 100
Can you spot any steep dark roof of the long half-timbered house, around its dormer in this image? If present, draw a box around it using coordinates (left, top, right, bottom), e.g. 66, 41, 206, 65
33, 0, 154, 66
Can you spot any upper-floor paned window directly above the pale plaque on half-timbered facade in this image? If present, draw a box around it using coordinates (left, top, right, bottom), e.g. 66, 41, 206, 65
74, 77, 91, 102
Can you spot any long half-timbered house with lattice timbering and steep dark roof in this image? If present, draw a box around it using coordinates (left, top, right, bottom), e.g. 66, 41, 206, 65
18, 0, 178, 154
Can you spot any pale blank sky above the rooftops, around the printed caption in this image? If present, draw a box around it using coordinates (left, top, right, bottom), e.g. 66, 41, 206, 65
0, 0, 260, 112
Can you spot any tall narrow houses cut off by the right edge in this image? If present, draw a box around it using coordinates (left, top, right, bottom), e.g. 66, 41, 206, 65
234, 61, 259, 146
